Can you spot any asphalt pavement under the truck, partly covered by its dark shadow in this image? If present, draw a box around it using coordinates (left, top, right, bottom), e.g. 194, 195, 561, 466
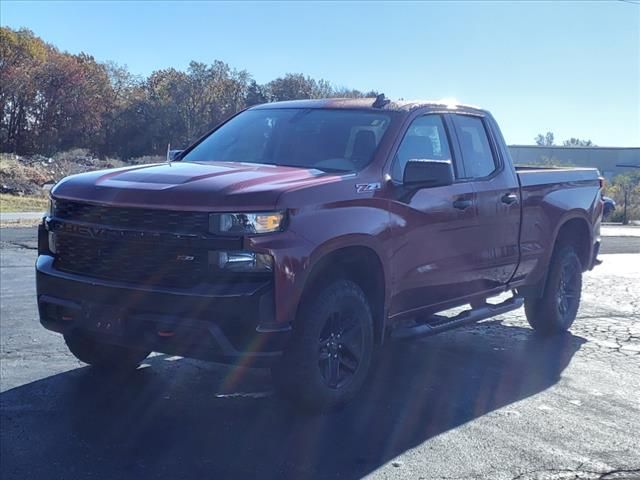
0, 228, 640, 480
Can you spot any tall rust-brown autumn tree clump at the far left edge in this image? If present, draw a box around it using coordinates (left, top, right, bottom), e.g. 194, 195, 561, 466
0, 28, 111, 153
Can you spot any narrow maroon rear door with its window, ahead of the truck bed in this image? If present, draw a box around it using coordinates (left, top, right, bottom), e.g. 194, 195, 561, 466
448, 114, 520, 293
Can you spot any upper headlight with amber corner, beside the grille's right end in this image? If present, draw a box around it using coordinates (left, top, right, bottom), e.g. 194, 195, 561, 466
209, 212, 284, 235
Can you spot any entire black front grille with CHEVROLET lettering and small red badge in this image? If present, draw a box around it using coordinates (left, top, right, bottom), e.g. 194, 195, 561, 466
48, 200, 248, 288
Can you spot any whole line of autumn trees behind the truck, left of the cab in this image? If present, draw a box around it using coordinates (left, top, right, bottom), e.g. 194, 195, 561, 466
0, 27, 377, 159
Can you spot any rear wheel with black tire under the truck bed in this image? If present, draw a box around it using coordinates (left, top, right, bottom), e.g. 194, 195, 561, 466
524, 246, 582, 335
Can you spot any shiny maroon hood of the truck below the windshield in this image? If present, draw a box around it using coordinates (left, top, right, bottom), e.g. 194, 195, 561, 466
52, 162, 341, 211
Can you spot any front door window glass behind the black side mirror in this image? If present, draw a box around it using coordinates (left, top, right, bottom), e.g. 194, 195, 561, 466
391, 115, 451, 181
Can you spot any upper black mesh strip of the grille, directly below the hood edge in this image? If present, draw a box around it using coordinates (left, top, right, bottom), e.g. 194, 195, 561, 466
53, 200, 209, 234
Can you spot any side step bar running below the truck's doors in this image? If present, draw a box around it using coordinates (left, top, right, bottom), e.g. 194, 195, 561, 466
391, 296, 524, 339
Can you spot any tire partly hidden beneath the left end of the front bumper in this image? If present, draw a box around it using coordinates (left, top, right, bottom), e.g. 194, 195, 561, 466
64, 330, 151, 371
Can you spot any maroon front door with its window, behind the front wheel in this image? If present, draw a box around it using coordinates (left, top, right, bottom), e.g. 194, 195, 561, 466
390, 114, 482, 316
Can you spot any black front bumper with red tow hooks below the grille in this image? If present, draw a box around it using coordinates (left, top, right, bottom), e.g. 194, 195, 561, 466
36, 252, 291, 367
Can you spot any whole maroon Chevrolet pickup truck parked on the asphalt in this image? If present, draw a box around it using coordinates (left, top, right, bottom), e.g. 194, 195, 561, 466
36, 97, 602, 409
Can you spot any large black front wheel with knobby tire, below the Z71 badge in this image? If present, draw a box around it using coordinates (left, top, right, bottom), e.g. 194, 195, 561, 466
272, 280, 373, 411
